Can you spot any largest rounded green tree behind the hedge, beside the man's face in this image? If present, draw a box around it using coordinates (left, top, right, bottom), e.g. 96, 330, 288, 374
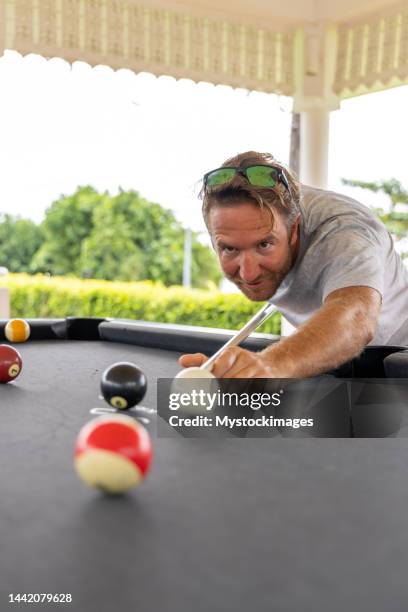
79, 191, 221, 287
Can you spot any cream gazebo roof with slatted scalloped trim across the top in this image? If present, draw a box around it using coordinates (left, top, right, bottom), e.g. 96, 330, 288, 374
0, 0, 408, 104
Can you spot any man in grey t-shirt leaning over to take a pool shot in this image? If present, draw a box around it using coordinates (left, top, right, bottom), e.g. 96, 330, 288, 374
180, 151, 408, 378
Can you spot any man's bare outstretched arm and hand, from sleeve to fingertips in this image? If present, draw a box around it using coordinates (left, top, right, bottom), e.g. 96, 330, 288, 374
179, 287, 381, 378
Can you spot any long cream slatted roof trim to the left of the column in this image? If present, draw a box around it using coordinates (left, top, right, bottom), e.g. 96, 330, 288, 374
0, 0, 294, 95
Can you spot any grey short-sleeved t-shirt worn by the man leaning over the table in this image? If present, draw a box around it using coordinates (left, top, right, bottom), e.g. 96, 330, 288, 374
270, 185, 408, 346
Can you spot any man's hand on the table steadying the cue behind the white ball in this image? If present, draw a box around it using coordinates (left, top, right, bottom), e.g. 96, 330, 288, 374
179, 346, 284, 378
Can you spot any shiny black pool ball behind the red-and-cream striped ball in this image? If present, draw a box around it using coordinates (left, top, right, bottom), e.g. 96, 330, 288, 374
101, 361, 147, 410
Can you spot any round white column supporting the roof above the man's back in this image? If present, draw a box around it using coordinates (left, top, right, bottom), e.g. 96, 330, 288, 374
300, 108, 330, 189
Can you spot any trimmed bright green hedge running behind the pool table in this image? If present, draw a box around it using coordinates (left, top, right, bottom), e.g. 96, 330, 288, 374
1, 274, 280, 334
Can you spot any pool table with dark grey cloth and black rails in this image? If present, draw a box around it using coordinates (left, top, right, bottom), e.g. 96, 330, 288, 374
0, 318, 408, 612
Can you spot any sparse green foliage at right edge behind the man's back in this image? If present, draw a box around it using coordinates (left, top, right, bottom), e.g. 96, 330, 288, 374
342, 178, 408, 257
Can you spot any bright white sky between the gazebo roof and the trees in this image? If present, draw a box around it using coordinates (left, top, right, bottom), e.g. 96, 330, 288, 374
0, 46, 408, 231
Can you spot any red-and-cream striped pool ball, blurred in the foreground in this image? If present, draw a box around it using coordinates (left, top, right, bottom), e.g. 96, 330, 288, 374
74, 414, 152, 493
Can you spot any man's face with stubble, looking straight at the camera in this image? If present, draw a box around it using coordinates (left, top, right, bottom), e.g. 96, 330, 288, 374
208, 202, 299, 302
